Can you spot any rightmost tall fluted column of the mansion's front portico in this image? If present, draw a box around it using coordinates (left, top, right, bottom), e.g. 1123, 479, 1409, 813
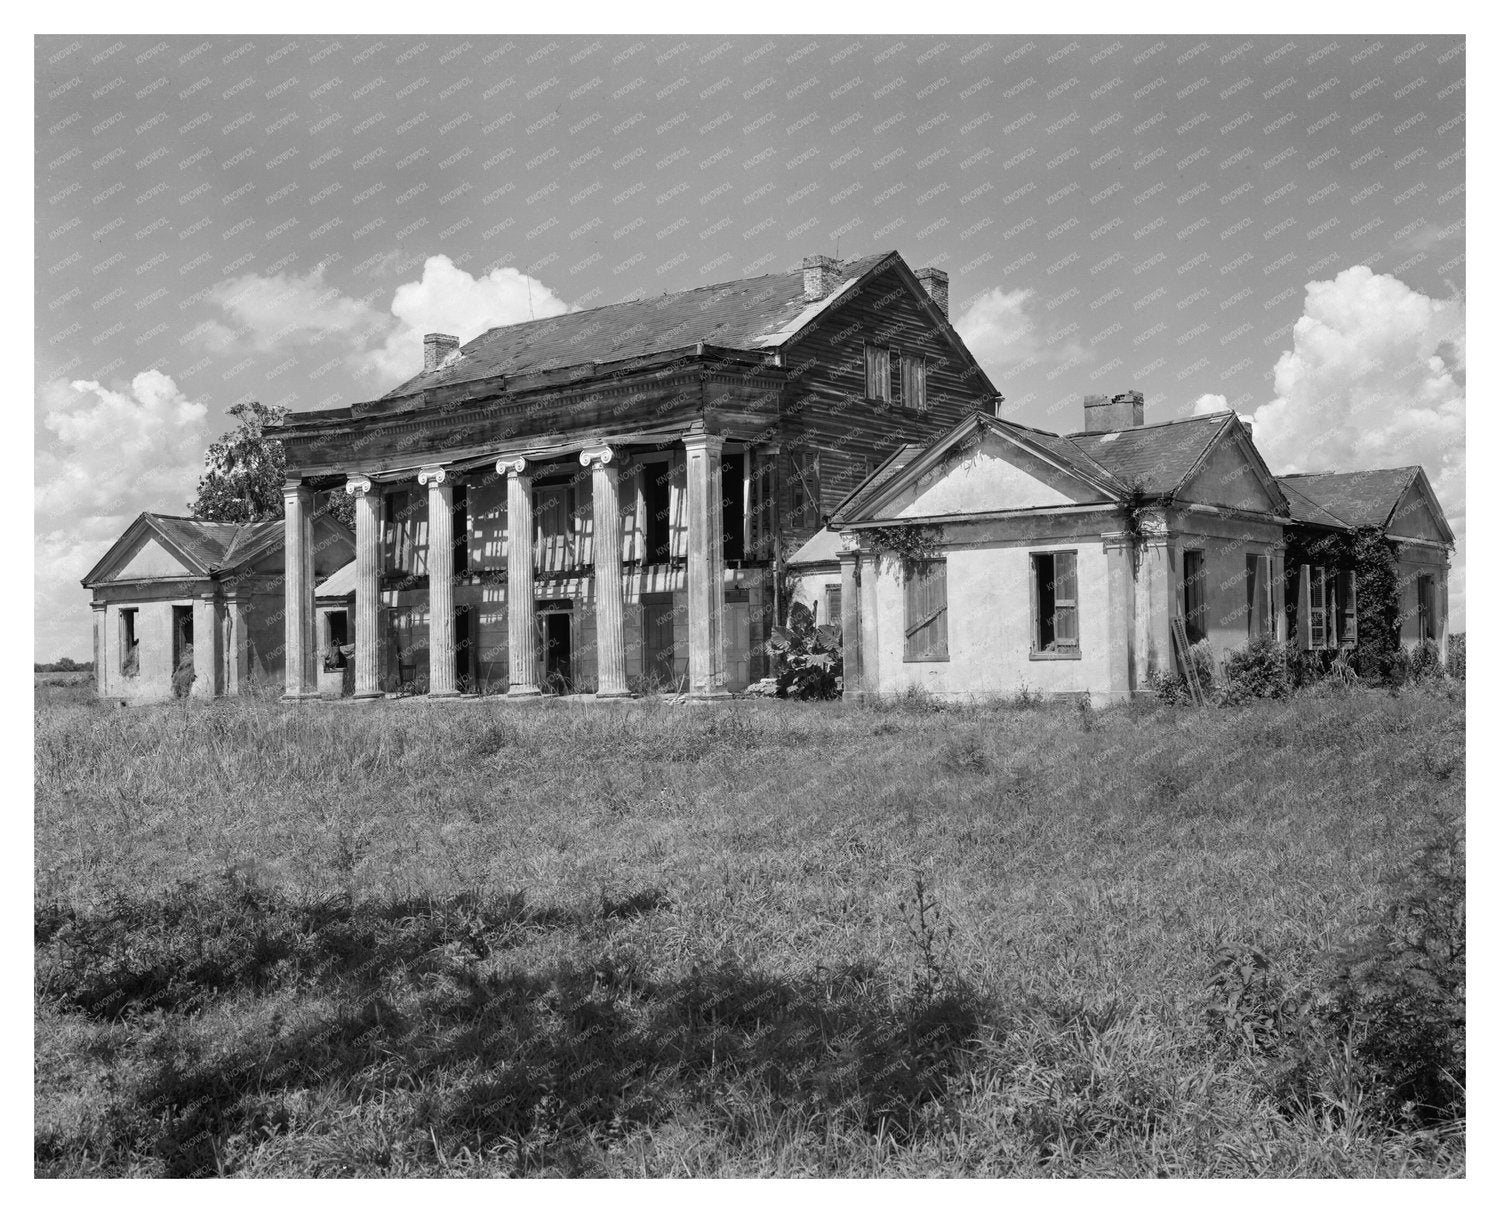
683, 433, 726, 699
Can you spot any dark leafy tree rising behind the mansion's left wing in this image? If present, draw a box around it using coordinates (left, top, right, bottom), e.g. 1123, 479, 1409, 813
189, 400, 354, 526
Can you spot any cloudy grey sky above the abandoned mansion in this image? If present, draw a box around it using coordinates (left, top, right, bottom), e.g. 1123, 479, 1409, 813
35, 34, 1466, 660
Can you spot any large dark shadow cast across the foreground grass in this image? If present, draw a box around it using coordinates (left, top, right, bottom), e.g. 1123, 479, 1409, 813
36, 882, 978, 1176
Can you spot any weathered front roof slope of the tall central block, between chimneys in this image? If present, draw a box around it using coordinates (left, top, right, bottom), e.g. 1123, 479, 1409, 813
381, 250, 900, 400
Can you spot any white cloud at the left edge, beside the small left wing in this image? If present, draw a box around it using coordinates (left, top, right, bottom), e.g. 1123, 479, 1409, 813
35, 370, 209, 660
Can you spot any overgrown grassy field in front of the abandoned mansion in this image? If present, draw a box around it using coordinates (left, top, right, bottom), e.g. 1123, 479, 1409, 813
35, 684, 1464, 1176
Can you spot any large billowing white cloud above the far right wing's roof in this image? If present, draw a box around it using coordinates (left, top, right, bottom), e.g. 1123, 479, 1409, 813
1254, 265, 1466, 630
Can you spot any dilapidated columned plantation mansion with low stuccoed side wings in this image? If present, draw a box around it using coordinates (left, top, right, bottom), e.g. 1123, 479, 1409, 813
84, 252, 1454, 702
